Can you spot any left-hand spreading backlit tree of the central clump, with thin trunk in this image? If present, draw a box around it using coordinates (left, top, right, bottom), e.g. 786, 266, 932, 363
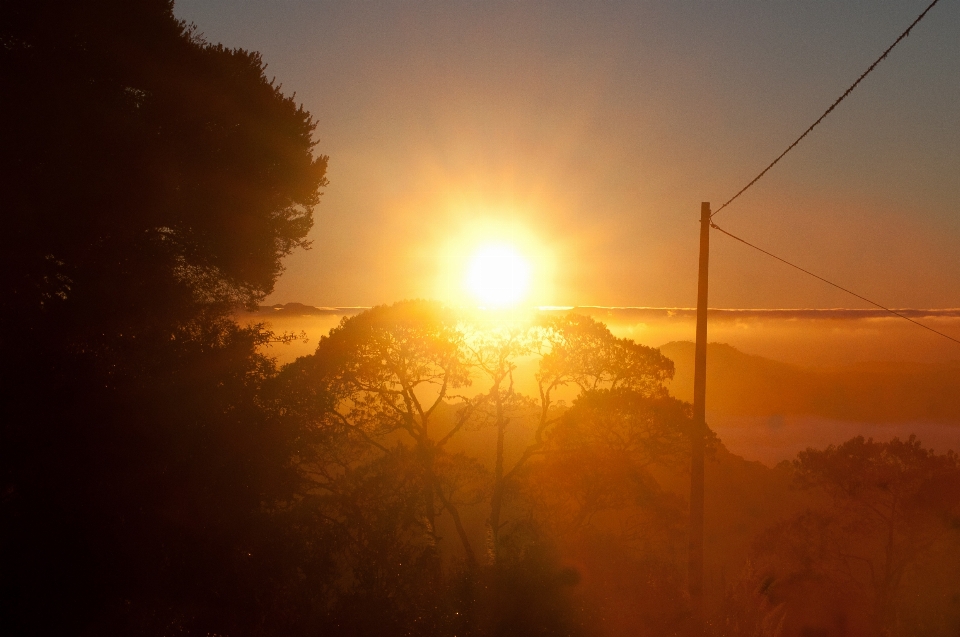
284, 301, 488, 577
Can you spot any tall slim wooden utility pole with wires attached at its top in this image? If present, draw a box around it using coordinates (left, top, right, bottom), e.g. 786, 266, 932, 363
687, 201, 710, 636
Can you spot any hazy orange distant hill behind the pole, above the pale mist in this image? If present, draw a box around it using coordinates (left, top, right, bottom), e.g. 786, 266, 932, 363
660, 341, 960, 423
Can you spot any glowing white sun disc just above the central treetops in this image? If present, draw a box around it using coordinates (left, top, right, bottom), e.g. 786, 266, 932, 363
465, 243, 531, 307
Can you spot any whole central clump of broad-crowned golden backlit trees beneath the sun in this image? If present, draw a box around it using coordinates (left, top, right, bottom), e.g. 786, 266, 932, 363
277, 301, 686, 634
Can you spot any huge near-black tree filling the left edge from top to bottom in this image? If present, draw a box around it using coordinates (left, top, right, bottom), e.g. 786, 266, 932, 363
0, 0, 326, 634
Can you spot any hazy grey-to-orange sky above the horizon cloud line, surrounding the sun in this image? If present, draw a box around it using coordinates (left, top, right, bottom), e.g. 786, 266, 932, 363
175, 0, 960, 308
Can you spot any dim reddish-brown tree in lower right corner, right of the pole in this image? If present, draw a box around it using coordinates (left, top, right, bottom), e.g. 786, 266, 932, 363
754, 436, 960, 635
